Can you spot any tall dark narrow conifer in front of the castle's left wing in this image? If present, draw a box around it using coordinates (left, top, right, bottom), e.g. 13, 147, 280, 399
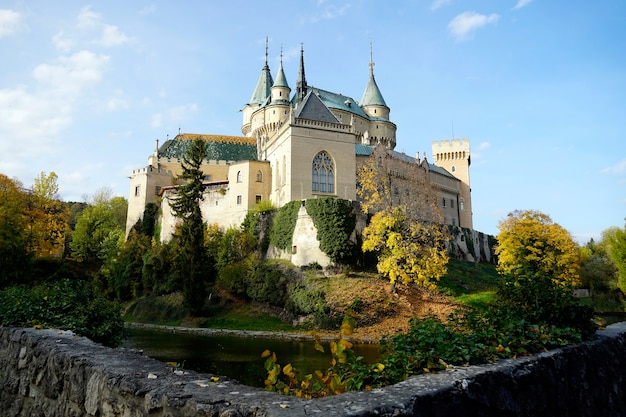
170, 138, 211, 314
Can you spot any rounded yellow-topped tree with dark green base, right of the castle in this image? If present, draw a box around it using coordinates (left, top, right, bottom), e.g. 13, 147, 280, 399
496, 210, 596, 336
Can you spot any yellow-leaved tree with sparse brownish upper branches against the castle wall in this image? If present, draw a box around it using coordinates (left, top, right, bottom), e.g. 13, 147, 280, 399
357, 146, 448, 288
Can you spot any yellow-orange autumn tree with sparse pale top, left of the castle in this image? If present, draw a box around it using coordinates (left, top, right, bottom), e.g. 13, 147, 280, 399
29, 172, 70, 257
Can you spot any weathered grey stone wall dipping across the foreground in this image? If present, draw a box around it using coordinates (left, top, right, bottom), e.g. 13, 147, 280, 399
0, 323, 626, 417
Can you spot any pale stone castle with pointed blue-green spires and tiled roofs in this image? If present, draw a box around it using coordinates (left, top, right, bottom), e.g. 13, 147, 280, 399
126, 45, 472, 250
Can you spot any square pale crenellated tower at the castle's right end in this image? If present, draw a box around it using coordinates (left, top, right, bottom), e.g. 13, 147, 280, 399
432, 138, 474, 229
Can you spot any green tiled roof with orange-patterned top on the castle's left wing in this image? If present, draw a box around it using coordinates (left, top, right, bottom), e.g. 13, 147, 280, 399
159, 134, 257, 161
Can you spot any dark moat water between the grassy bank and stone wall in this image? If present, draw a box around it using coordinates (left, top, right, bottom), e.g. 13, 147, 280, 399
123, 329, 378, 387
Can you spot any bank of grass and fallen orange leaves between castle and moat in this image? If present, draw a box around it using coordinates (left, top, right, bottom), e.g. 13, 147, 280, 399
125, 260, 498, 342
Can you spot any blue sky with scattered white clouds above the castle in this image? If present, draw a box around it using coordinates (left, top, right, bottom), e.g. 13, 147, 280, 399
0, 0, 626, 244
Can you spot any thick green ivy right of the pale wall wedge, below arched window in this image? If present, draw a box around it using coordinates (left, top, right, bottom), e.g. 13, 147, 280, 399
306, 197, 356, 262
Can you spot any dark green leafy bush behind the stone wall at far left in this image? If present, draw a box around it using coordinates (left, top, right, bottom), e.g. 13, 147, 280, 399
0, 279, 124, 346
